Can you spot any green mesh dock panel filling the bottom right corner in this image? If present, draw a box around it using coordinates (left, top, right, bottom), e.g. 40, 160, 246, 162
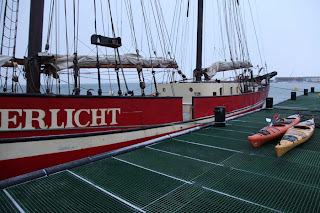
195, 167, 320, 212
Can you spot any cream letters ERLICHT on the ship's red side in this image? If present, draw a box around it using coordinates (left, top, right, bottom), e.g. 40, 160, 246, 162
0, 108, 121, 130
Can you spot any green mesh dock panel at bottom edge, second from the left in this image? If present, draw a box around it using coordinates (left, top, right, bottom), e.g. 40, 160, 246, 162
8, 172, 133, 212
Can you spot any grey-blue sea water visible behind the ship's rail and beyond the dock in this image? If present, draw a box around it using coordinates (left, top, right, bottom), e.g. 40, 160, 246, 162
27, 82, 320, 104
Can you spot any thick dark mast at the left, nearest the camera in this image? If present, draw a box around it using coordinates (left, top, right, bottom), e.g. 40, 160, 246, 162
26, 0, 44, 93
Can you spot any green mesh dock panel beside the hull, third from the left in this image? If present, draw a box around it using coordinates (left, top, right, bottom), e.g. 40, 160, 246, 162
72, 159, 183, 207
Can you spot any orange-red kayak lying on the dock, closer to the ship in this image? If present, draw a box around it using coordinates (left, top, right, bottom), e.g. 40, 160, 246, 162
248, 114, 300, 147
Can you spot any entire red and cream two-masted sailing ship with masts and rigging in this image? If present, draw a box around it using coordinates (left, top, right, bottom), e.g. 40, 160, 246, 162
0, 0, 276, 180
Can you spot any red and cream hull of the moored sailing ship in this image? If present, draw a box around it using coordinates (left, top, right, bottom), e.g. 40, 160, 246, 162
0, 87, 269, 180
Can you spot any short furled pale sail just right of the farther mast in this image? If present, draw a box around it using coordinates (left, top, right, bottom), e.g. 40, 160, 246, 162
205, 61, 252, 79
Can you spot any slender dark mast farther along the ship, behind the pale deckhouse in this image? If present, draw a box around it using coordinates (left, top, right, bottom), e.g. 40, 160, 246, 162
194, 0, 203, 81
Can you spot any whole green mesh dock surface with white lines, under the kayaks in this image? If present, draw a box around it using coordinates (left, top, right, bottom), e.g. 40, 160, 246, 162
0, 93, 320, 212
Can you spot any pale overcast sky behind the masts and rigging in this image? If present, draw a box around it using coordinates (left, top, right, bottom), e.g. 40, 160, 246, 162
1, 0, 320, 85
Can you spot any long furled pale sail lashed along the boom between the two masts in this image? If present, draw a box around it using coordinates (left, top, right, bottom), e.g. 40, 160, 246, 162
55, 54, 178, 71
